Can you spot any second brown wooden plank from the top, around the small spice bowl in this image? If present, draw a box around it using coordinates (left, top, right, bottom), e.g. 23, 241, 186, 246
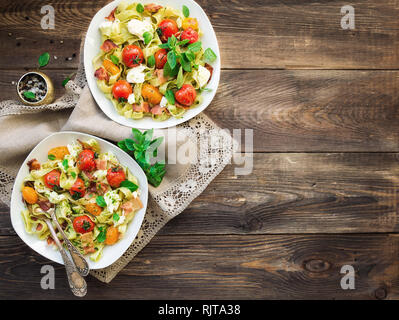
0, 70, 399, 152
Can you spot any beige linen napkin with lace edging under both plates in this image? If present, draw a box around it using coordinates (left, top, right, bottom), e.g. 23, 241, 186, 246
0, 80, 233, 282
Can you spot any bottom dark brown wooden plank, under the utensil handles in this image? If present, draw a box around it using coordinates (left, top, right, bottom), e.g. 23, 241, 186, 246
0, 234, 399, 299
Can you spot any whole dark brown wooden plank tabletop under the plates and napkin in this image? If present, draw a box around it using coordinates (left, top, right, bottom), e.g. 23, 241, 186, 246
0, 0, 399, 299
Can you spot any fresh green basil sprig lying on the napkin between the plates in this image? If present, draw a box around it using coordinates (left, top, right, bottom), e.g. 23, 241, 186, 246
118, 128, 166, 187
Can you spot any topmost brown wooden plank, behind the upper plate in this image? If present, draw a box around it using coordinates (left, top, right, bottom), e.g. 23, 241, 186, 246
0, 0, 399, 69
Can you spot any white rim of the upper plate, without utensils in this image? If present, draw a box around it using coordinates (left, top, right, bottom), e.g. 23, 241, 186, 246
84, 0, 220, 129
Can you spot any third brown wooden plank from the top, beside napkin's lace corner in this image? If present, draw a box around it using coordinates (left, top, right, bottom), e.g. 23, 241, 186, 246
0, 153, 399, 235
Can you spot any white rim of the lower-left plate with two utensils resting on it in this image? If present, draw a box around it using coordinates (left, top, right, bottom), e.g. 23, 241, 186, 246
10, 132, 148, 269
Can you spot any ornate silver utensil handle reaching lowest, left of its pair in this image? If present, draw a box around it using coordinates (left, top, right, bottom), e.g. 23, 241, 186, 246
46, 219, 87, 297
